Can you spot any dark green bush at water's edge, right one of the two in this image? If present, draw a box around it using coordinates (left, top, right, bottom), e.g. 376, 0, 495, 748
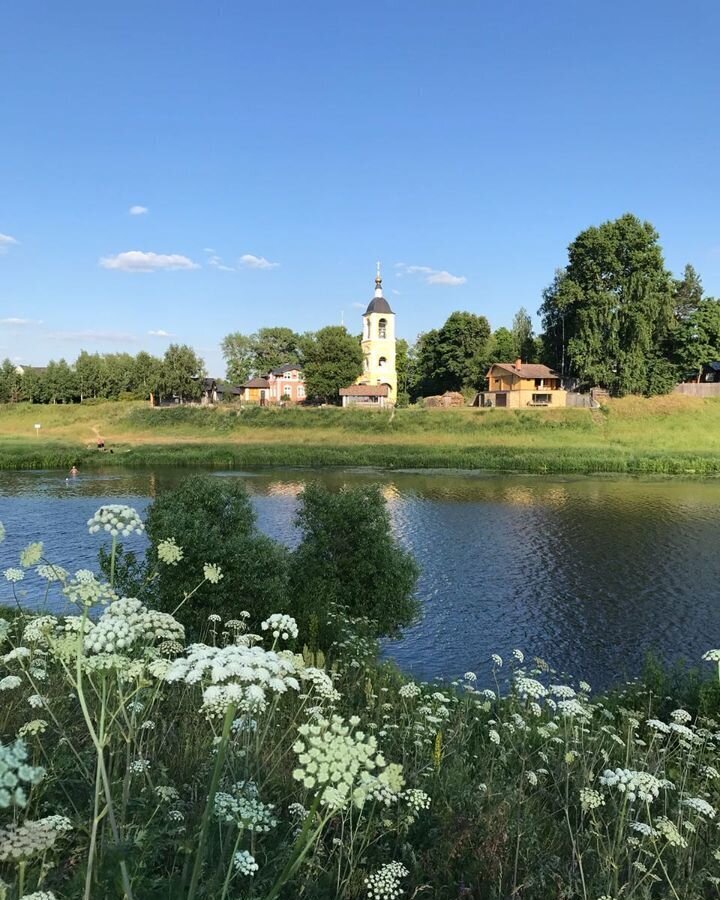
290, 484, 418, 643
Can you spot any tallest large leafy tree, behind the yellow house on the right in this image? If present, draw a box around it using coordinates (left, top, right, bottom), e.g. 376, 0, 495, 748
541, 214, 673, 394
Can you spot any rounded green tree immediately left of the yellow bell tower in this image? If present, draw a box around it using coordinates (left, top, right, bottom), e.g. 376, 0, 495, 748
303, 325, 362, 403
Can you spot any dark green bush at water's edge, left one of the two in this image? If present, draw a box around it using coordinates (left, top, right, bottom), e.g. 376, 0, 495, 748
141, 475, 289, 638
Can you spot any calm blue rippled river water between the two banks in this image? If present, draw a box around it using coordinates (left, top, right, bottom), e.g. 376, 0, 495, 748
0, 469, 720, 687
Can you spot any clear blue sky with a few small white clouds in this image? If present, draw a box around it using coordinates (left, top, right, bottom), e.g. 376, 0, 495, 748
0, 0, 720, 374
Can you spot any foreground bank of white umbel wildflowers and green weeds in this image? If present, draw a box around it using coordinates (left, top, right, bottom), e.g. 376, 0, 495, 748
0, 506, 720, 900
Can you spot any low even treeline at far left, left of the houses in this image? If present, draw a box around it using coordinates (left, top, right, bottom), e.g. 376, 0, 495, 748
0, 344, 205, 403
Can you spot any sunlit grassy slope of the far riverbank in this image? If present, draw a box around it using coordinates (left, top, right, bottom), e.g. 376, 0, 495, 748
0, 395, 720, 475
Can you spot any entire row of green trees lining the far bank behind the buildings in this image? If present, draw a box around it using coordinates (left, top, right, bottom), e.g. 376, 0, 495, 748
7, 214, 720, 403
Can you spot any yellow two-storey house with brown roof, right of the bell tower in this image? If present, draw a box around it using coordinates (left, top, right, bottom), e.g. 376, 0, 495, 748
473, 359, 567, 409
